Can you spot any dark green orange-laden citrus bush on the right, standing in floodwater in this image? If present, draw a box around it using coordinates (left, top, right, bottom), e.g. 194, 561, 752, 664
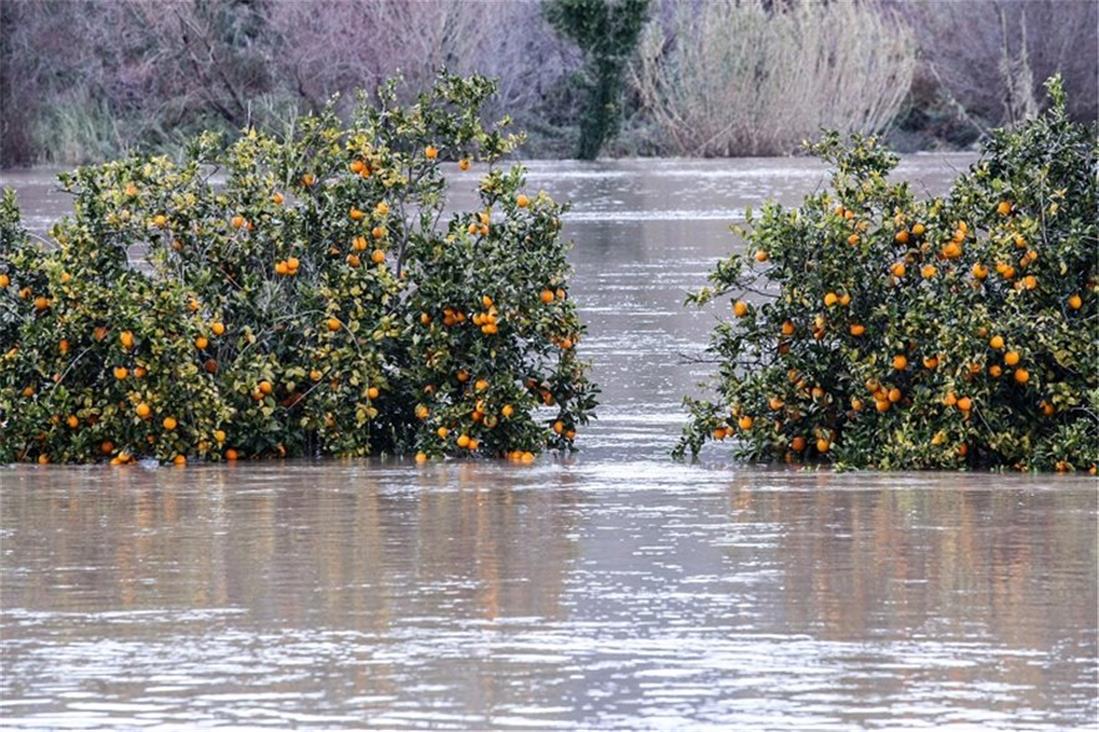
676, 80, 1099, 470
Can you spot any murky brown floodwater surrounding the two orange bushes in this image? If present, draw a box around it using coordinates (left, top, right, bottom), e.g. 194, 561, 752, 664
0, 156, 1099, 730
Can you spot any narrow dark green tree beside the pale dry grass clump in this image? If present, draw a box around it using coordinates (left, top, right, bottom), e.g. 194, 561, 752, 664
542, 0, 648, 160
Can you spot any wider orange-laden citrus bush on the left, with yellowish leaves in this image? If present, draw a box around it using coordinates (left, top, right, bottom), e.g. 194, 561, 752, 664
0, 74, 596, 462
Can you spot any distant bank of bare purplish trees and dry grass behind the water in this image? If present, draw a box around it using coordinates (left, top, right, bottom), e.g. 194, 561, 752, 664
0, 0, 1099, 166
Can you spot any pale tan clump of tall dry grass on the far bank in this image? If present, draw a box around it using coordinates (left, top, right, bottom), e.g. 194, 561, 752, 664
632, 0, 915, 156
